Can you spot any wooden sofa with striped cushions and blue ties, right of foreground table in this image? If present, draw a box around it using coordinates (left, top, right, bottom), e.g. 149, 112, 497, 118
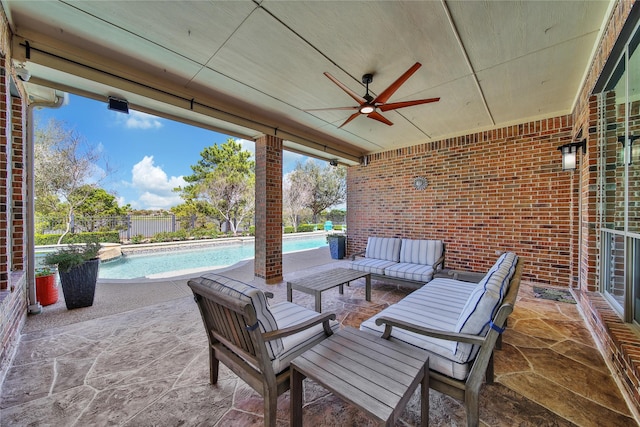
360, 252, 522, 426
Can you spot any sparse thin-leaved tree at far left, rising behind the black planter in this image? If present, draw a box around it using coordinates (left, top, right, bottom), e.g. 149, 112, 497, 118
34, 119, 109, 243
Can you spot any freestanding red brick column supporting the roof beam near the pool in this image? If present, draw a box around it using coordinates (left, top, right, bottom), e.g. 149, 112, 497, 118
254, 135, 282, 284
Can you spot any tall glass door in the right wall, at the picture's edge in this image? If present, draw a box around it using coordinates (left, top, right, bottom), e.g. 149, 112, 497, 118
598, 23, 640, 323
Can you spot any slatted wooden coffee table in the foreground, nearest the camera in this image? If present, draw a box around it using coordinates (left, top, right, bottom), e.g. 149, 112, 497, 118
290, 328, 429, 426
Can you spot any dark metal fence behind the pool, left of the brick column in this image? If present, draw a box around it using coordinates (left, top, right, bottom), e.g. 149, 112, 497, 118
35, 214, 212, 240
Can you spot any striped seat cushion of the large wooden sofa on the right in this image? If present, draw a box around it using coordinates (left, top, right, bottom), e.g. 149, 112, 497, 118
360, 278, 476, 379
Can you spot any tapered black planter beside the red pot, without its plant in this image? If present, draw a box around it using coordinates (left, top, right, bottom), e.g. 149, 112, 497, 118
58, 258, 100, 310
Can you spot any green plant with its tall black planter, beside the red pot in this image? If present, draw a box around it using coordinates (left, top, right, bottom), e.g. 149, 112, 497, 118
44, 242, 100, 310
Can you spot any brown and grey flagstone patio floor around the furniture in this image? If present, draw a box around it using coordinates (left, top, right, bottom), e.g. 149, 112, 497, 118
0, 249, 637, 427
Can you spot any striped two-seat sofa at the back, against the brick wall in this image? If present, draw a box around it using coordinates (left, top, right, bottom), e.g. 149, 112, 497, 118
351, 237, 444, 288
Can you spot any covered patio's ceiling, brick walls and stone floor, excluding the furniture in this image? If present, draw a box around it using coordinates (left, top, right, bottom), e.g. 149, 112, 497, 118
0, 0, 640, 425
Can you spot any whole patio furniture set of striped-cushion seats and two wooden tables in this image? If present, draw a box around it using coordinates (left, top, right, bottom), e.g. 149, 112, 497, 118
188, 238, 522, 426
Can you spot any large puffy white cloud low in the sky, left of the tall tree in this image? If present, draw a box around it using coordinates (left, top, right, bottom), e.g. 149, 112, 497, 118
131, 156, 186, 209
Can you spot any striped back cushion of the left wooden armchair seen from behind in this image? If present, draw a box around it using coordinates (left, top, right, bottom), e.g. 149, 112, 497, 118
199, 273, 282, 360
